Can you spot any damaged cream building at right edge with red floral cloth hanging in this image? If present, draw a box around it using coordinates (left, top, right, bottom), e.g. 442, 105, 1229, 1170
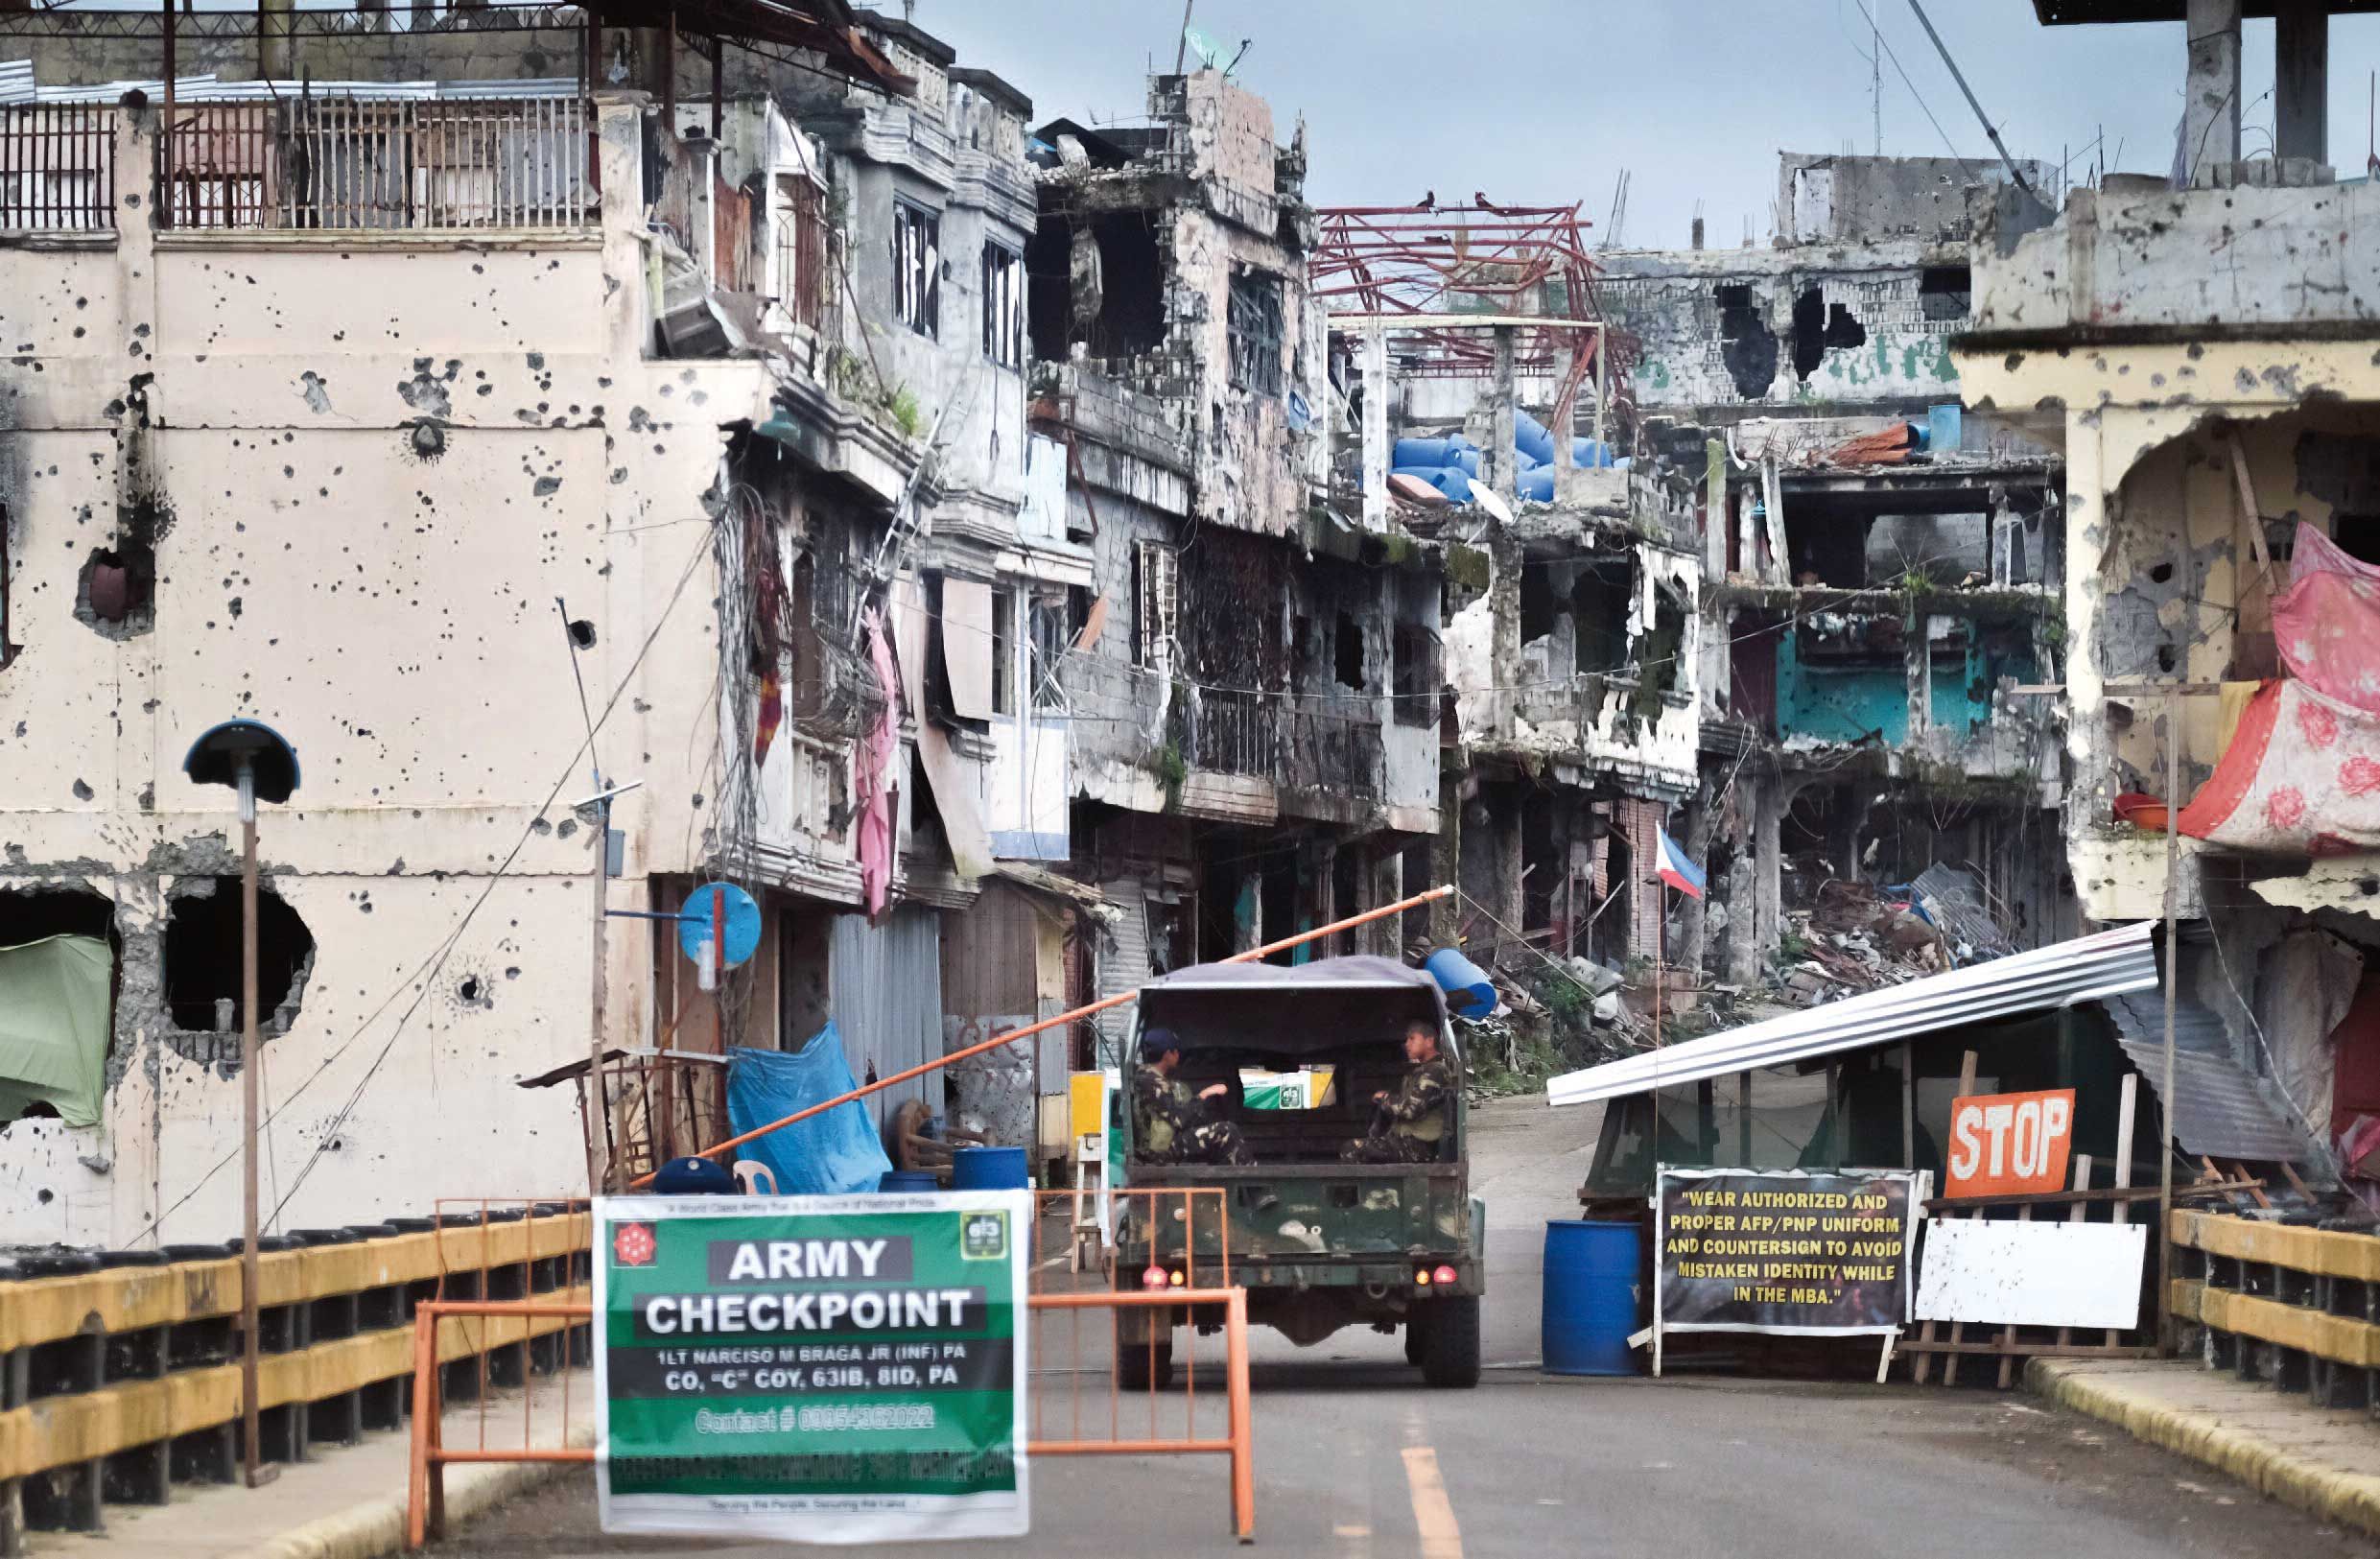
1951, 0, 2380, 1178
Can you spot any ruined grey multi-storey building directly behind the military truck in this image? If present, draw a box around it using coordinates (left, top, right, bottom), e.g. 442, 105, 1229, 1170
1025, 69, 1440, 1064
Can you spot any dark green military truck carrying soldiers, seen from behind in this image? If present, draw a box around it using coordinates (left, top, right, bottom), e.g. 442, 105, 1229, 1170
1114, 957, 1485, 1390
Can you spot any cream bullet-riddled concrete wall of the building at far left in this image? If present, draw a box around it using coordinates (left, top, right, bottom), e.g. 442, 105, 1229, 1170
0, 109, 766, 1245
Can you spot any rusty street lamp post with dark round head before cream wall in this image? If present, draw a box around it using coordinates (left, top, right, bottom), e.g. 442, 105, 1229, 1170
181, 719, 297, 1488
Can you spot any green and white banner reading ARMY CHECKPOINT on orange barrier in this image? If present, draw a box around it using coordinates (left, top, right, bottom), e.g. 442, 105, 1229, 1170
595, 1190, 1033, 1543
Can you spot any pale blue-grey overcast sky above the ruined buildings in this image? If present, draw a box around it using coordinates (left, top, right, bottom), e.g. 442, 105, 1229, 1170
908, 0, 2380, 248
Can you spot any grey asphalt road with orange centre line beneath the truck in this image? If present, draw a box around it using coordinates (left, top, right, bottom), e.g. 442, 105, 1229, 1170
440, 1099, 2380, 1559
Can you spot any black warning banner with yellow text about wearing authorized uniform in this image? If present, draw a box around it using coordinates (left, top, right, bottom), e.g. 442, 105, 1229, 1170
1654, 1169, 1916, 1335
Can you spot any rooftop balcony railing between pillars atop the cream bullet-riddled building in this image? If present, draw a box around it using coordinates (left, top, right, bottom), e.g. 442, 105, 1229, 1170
157, 98, 595, 231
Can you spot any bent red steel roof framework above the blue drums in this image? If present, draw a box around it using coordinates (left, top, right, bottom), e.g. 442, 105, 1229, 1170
1307, 195, 1633, 436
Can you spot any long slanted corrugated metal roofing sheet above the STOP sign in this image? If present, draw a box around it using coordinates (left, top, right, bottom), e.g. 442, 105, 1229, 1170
1544, 921, 2156, 1104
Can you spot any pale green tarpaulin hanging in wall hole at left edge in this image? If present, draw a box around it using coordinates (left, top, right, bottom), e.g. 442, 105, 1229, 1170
0, 935, 114, 1125
